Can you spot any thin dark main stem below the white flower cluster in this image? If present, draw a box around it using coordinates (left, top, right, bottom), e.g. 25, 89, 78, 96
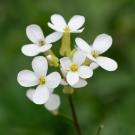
68, 95, 82, 135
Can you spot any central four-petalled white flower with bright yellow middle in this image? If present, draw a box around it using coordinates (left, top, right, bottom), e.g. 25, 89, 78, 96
60, 51, 93, 86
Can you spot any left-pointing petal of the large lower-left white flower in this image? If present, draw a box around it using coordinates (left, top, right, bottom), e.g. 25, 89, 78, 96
17, 70, 38, 87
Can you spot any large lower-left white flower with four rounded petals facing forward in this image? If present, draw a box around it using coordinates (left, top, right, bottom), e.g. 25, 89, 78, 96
17, 56, 61, 104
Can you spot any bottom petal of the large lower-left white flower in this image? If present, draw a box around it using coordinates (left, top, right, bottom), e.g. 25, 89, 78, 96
33, 85, 50, 104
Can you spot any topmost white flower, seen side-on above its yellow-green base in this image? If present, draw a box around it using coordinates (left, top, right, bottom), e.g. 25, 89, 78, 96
48, 14, 85, 33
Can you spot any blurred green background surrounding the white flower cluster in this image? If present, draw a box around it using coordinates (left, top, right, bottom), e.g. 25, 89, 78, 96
0, 0, 135, 135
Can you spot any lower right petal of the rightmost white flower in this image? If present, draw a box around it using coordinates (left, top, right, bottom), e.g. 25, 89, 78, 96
96, 56, 118, 71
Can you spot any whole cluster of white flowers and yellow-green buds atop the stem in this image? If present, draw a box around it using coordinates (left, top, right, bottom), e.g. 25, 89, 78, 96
17, 14, 118, 111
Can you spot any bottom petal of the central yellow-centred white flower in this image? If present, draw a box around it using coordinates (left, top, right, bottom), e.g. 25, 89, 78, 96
67, 71, 79, 85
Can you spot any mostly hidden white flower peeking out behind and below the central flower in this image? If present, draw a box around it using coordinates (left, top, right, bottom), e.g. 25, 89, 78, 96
61, 68, 88, 88
